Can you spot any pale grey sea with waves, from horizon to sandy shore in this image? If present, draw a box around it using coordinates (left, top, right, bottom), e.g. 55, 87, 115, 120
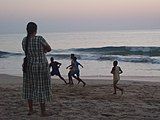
0, 30, 160, 79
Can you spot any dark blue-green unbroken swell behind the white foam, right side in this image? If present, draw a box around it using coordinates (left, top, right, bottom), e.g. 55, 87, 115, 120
71, 46, 160, 56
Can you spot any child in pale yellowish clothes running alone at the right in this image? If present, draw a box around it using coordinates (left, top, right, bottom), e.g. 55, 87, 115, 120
111, 61, 123, 94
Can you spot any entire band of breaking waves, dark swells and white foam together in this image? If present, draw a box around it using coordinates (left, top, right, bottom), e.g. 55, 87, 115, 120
0, 46, 160, 64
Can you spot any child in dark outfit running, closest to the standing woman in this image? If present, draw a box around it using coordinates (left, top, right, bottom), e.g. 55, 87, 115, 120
49, 57, 67, 84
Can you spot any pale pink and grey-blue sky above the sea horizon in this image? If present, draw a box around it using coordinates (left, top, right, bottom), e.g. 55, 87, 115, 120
0, 0, 160, 33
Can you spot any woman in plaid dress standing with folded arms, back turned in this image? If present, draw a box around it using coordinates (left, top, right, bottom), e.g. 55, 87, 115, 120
22, 22, 51, 116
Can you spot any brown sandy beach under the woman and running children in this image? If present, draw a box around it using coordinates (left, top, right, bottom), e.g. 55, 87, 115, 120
0, 74, 160, 120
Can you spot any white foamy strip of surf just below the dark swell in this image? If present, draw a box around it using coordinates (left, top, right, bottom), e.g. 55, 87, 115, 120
49, 53, 160, 64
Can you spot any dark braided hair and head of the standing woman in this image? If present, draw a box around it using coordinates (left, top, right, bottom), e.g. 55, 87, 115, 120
26, 22, 37, 39
